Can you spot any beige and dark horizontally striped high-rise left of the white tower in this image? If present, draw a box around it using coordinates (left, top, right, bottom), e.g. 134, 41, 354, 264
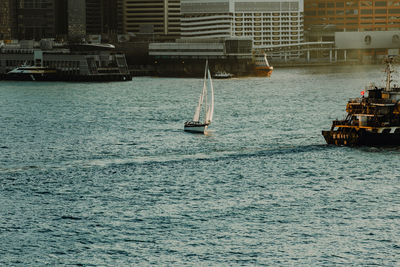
122, 0, 181, 35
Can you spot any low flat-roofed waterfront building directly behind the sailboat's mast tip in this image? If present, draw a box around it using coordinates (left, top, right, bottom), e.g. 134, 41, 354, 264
149, 38, 254, 77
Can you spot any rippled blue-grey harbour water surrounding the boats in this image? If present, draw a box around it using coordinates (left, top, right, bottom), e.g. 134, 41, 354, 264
0, 66, 400, 266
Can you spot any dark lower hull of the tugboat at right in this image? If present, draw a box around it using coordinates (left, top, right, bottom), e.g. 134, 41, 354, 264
322, 130, 400, 146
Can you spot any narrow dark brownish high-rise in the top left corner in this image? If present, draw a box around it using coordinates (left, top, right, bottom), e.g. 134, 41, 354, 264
0, 0, 17, 39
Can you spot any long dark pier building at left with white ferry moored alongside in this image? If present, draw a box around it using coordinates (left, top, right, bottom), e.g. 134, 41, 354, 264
0, 44, 132, 82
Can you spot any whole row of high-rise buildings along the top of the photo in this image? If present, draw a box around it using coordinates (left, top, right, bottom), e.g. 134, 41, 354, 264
0, 0, 400, 41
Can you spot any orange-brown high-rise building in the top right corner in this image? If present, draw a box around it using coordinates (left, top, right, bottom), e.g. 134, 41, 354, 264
304, 0, 400, 41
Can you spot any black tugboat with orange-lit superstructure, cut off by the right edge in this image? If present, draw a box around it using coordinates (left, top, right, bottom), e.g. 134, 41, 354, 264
322, 57, 400, 146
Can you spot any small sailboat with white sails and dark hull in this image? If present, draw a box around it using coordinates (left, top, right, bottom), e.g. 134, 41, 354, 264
183, 61, 214, 134
